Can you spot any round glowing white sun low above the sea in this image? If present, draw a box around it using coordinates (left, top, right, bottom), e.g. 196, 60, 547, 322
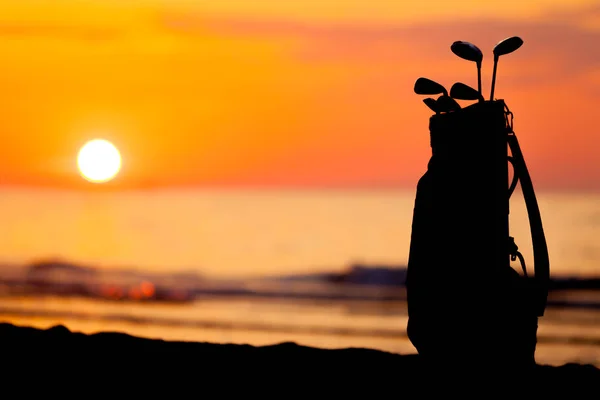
77, 139, 121, 183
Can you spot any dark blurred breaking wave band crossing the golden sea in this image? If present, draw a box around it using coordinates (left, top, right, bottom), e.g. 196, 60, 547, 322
0, 260, 600, 309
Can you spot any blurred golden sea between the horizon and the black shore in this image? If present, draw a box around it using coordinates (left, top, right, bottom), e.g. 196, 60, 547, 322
0, 187, 600, 367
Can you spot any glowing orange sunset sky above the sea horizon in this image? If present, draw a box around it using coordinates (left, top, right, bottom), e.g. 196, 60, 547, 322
0, 0, 600, 189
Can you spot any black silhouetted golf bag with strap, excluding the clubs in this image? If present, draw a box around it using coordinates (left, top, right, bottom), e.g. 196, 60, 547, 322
406, 100, 549, 366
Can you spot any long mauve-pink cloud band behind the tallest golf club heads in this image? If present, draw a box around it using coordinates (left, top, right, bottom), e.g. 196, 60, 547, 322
162, 6, 600, 85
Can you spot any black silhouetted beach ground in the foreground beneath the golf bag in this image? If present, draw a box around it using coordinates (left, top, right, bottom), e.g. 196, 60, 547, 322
0, 324, 600, 399
